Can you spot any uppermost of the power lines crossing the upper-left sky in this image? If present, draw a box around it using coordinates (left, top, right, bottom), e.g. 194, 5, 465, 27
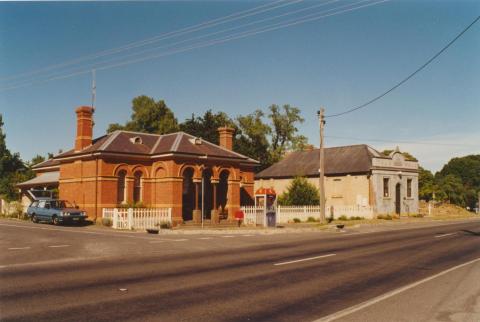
0, 0, 304, 81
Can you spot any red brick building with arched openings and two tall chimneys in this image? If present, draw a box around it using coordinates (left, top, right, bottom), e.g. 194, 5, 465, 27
20, 106, 258, 223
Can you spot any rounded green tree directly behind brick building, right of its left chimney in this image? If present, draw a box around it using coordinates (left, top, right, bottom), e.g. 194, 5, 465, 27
107, 95, 178, 134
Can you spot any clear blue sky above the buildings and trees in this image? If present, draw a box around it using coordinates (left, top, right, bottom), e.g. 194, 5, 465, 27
0, 0, 480, 171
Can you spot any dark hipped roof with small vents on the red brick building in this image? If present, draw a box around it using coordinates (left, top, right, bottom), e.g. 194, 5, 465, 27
55, 131, 258, 164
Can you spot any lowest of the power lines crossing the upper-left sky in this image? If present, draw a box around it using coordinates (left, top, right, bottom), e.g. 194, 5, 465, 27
0, 0, 390, 91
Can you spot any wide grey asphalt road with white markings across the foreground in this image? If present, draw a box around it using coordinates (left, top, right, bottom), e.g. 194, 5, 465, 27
0, 220, 480, 321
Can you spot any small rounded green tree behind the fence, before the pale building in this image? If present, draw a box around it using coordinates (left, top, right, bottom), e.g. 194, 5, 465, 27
278, 177, 320, 206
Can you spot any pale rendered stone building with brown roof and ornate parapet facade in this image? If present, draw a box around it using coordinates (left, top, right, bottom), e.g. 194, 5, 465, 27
255, 144, 418, 214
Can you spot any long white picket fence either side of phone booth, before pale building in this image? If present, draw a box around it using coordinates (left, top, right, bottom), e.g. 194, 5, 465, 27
241, 206, 375, 226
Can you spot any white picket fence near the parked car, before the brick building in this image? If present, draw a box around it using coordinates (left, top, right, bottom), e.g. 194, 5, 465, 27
102, 208, 172, 230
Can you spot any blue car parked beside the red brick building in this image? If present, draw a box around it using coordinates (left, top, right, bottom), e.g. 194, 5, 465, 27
27, 198, 87, 225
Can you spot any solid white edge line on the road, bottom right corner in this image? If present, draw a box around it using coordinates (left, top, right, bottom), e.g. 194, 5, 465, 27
313, 258, 480, 322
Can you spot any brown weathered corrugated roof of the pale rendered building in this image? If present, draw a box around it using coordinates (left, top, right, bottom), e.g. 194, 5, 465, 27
255, 144, 379, 179
